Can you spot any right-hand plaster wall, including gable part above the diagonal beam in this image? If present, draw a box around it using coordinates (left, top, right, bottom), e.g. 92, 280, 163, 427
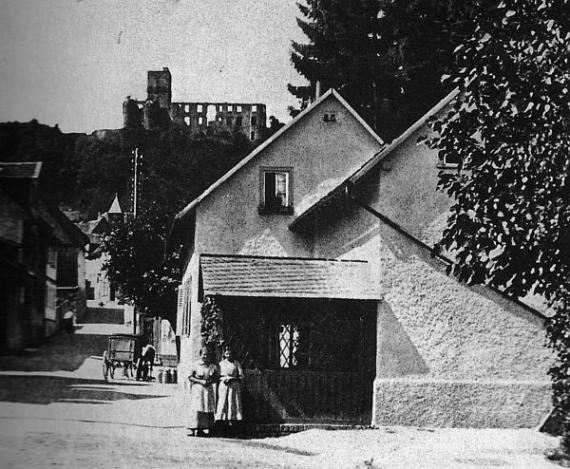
308, 119, 553, 427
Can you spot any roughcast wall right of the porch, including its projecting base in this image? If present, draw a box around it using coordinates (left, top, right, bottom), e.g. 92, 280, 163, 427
368, 221, 553, 427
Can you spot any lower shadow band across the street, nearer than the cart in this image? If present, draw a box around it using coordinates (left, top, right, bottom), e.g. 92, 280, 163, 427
0, 375, 168, 404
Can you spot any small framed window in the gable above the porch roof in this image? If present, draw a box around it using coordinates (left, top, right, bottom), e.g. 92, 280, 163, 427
259, 168, 293, 214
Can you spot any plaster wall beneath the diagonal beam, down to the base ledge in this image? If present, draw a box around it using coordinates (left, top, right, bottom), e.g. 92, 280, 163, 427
315, 196, 551, 380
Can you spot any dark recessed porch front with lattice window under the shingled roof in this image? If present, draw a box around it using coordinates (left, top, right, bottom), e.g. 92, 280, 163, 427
218, 297, 376, 424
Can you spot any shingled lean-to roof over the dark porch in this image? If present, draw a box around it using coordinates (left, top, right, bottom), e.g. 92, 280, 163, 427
200, 254, 382, 300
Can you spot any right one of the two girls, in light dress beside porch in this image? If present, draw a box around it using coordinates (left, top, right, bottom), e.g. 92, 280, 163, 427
212, 348, 243, 429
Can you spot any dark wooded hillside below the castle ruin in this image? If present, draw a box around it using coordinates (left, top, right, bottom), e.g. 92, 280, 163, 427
0, 121, 252, 220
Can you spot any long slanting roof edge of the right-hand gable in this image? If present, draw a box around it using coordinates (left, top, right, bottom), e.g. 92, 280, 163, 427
289, 89, 459, 230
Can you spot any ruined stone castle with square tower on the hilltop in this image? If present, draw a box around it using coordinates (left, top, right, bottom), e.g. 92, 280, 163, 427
123, 67, 266, 141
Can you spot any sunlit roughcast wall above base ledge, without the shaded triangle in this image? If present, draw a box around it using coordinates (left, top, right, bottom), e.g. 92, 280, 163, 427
378, 223, 551, 380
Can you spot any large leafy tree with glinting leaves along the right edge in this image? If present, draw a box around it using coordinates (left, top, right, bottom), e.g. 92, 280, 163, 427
429, 0, 570, 447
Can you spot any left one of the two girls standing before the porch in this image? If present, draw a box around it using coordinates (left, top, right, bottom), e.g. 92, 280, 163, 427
186, 349, 218, 436
